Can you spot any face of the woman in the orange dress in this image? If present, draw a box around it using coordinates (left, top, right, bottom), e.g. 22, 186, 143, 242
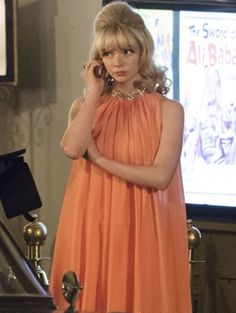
102, 46, 141, 91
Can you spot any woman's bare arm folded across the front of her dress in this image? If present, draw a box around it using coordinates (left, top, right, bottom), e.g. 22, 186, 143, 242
88, 99, 184, 190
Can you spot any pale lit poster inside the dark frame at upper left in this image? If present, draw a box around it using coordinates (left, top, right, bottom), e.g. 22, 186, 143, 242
0, 0, 7, 76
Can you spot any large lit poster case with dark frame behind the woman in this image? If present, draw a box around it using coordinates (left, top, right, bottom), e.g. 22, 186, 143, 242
103, 0, 236, 221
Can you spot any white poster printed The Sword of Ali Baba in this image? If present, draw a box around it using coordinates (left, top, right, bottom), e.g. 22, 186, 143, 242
179, 11, 236, 206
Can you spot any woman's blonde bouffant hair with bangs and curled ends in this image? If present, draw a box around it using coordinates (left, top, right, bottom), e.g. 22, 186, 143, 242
90, 1, 169, 95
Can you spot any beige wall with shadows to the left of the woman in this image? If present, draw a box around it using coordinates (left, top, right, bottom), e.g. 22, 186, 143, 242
0, 0, 101, 269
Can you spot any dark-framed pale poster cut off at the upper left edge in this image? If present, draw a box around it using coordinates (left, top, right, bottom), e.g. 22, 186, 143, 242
0, 0, 18, 85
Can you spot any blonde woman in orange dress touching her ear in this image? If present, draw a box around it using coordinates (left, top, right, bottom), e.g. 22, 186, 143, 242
50, 1, 191, 313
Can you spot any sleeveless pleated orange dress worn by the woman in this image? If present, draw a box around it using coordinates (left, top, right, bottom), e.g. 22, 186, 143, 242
50, 93, 192, 313
